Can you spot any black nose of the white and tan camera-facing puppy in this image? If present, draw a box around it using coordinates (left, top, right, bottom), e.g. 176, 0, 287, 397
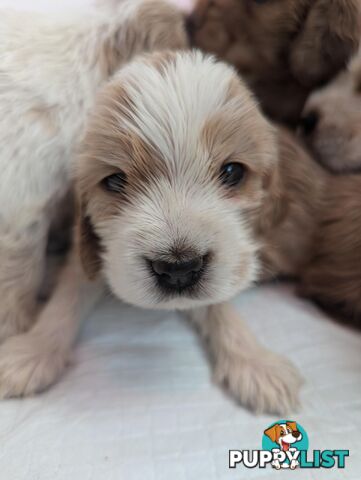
150, 256, 206, 292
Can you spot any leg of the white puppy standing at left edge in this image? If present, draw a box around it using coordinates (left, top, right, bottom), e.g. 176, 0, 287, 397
0, 228, 46, 343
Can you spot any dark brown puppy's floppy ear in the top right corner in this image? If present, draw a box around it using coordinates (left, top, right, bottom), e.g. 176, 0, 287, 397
290, 0, 361, 87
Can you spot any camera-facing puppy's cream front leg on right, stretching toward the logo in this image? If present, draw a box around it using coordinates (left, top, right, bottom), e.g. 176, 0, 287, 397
190, 303, 302, 414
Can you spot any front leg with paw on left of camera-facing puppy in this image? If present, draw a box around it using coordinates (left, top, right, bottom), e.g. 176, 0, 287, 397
0, 253, 103, 398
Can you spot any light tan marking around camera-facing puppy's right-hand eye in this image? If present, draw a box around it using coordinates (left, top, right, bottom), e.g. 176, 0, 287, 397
201, 77, 278, 211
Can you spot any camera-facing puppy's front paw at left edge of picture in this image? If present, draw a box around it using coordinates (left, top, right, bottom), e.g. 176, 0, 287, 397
0, 333, 68, 398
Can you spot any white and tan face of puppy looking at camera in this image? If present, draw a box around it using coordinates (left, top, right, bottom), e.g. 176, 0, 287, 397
78, 53, 277, 309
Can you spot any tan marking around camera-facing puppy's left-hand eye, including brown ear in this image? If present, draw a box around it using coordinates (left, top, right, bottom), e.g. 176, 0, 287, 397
77, 79, 168, 278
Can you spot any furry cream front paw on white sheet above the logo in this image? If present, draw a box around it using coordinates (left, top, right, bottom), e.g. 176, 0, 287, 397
215, 349, 303, 415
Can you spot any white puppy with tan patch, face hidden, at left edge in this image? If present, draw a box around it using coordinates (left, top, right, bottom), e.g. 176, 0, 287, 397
0, 0, 187, 342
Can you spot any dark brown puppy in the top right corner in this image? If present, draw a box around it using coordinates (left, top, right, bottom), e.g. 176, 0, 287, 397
189, 0, 361, 126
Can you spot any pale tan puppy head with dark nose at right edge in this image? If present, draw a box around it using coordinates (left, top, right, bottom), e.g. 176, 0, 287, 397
300, 51, 361, 172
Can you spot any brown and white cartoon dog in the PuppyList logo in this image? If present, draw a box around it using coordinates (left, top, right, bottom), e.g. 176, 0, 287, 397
264, 422, 302, 470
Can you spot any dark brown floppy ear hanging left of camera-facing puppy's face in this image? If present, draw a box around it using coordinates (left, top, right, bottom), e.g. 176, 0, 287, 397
76, 194, 101, 280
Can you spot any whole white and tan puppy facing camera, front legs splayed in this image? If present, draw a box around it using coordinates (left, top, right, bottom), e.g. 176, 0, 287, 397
0, 52, 300, 412
